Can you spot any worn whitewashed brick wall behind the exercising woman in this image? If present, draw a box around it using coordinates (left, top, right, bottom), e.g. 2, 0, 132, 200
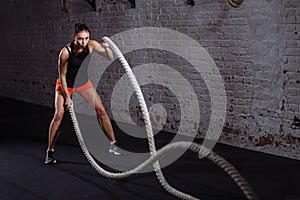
0, 0, 300, 159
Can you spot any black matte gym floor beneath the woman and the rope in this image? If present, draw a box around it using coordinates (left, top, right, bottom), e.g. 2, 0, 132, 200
0, 98, 300, 200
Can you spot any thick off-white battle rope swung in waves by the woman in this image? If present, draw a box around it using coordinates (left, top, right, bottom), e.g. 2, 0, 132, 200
69, 37, 257, 200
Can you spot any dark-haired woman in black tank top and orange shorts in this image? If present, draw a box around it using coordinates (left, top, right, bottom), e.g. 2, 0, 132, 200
45, 23, 122, 164
